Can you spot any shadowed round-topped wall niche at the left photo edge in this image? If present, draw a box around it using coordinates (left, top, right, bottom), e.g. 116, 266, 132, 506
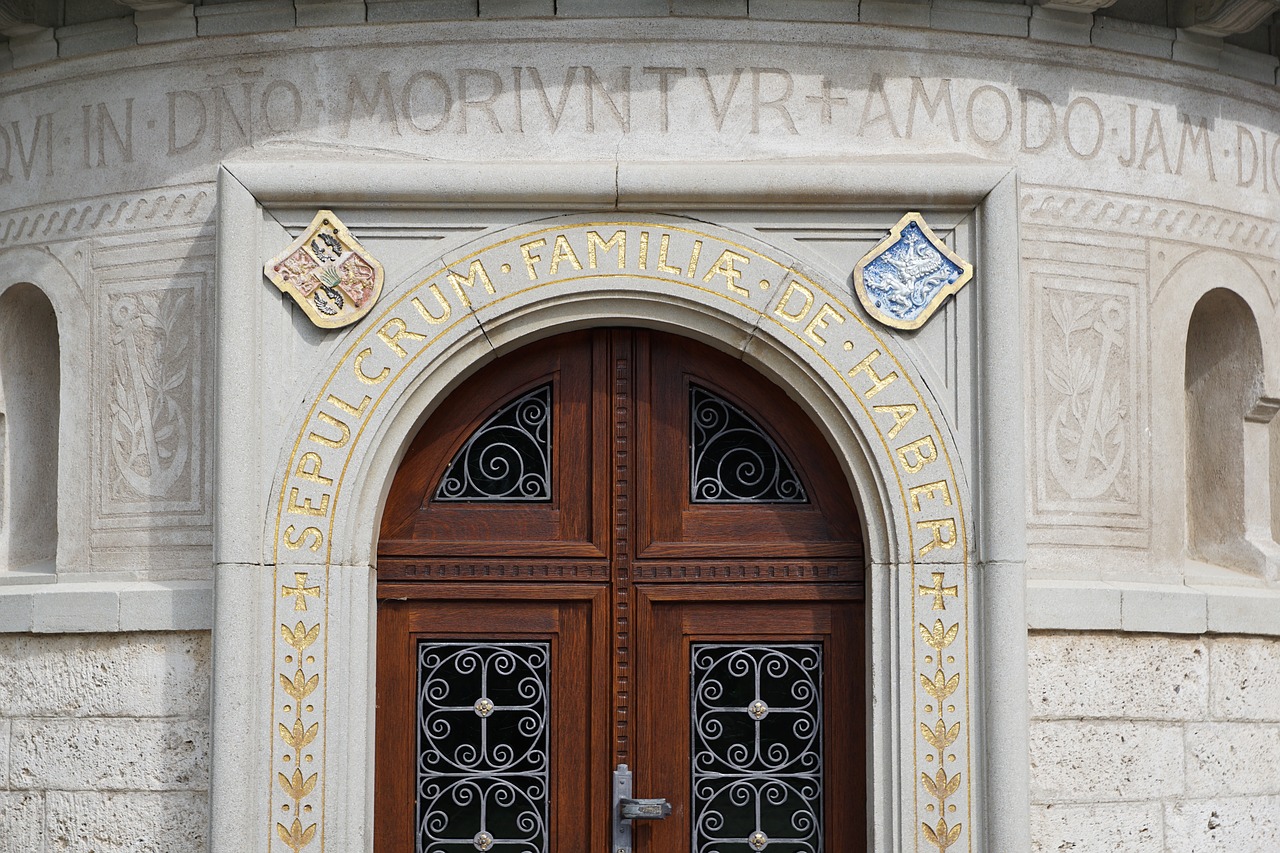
0, 283, 61, 571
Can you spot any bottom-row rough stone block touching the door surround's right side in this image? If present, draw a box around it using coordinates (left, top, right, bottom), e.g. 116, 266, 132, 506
1032, 802, 1166, 853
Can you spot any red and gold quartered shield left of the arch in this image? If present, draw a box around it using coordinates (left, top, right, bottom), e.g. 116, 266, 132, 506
262, 210, 383, 329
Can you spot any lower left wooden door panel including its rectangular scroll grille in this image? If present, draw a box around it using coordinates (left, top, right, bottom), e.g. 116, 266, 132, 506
374, 584, 609, 853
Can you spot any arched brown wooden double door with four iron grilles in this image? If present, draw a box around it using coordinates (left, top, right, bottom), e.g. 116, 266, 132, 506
375, 329, 865, 853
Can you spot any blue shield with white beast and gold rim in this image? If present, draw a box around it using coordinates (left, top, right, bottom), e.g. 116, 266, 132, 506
854, 213, 973, 329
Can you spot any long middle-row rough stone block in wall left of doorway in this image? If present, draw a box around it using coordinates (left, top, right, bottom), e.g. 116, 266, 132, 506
9, 717, 209, 792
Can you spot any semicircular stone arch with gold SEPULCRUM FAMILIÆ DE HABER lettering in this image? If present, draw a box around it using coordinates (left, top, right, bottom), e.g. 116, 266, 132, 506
268, 214, 970, 565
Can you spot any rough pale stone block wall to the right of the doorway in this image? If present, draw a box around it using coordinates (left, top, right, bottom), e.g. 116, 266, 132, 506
1028, 633, 1280, 853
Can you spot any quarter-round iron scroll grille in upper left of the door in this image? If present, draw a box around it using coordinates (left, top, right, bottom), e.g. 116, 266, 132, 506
435, 383, 552, 502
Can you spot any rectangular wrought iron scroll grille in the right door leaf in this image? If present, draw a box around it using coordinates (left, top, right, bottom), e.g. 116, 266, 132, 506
691, 643, 823, 853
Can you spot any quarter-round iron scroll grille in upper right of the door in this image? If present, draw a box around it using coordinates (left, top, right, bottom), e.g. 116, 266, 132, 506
689, 386, 809, 503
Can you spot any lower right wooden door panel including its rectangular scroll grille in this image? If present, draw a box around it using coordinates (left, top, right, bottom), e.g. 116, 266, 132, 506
635, 584, 865, 853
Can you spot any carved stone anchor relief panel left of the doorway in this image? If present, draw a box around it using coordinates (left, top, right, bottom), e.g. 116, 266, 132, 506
91, 237, 212, 545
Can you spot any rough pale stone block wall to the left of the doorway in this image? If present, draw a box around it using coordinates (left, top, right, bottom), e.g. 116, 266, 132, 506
0, 633, 209, 853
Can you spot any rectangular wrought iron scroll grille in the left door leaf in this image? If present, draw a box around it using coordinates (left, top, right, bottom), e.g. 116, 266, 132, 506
416, 640, 550, 853
